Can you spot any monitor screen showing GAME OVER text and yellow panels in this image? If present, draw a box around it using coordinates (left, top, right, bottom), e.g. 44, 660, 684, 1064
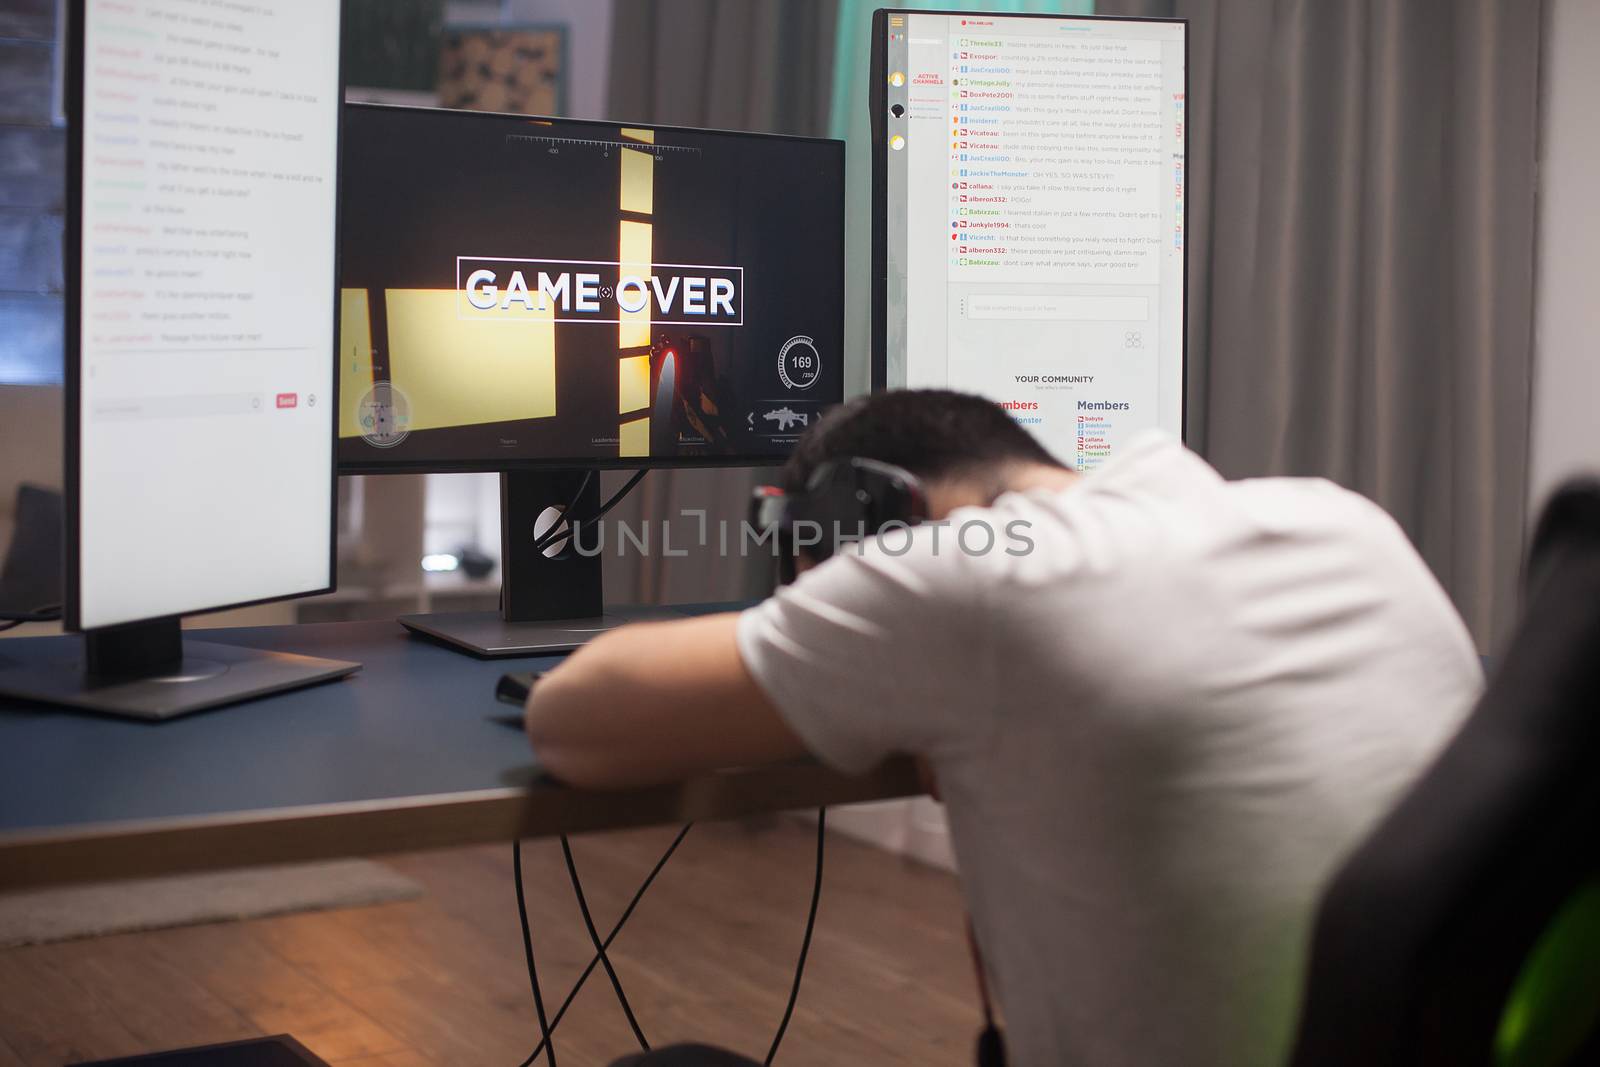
339, 106, 845, 469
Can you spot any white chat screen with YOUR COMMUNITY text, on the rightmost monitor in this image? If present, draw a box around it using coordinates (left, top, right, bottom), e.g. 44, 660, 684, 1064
875, 13, 1186, 470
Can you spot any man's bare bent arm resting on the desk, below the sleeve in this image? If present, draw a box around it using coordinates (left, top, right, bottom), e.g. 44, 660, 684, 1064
526, 613, 805, 789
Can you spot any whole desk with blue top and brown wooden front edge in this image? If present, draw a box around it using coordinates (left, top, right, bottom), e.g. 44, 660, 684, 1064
0, 621, 920, 891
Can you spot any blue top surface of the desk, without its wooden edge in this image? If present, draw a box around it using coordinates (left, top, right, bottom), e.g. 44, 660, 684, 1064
0, 621, 558, 832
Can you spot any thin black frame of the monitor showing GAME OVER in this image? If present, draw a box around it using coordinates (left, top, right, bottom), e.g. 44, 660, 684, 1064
333, 101, 850, 475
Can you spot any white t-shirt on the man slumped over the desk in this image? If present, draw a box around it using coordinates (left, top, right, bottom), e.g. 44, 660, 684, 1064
739, 435, 1483, 1067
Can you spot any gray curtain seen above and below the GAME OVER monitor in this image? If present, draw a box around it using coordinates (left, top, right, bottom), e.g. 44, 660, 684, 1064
602, 0, 838, 603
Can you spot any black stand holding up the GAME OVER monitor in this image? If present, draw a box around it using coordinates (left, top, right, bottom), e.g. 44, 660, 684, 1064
400, 470, 683, 657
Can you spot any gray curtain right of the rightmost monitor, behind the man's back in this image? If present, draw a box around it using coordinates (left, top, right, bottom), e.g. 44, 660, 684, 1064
1096, 0, 1544, 648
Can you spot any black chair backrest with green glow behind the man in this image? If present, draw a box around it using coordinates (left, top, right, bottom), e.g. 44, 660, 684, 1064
1290, 482, 1600, 1067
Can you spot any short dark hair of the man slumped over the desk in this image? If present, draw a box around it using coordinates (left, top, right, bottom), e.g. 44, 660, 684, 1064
784, 389, 1062, 493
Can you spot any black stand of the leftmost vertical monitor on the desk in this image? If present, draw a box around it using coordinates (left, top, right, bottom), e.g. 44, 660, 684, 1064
0, 617, 362, 720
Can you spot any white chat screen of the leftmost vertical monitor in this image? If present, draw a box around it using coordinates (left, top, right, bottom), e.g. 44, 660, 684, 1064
69, 0, 341, 629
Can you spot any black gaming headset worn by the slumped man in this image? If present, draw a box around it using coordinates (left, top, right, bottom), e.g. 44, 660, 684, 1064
750, 456, 928, 584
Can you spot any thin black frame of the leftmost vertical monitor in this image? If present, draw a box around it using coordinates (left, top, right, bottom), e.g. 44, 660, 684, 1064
61, 0, 344, 632
